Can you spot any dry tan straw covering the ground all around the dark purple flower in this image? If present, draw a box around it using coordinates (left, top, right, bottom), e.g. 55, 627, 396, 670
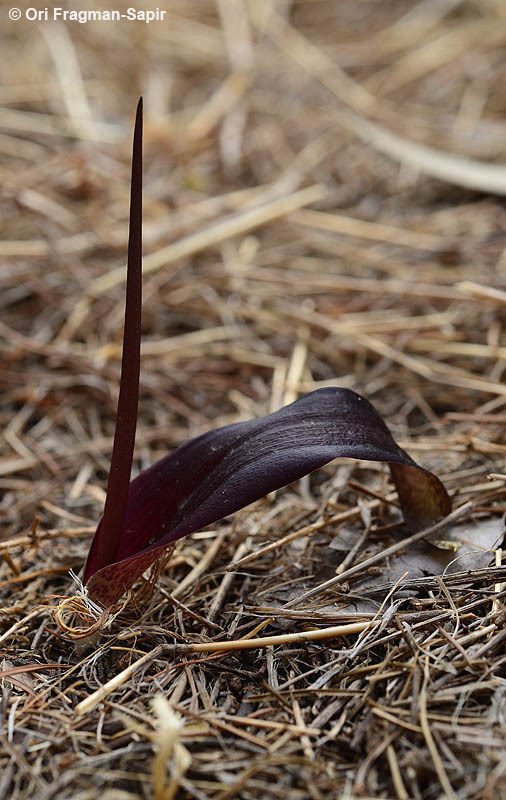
0, 0, 506, 800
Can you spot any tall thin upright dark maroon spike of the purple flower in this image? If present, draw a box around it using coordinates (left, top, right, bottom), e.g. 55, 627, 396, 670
85, 97, 142, 582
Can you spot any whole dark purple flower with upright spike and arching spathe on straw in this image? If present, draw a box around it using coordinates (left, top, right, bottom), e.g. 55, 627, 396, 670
84, 99, 451, 608
